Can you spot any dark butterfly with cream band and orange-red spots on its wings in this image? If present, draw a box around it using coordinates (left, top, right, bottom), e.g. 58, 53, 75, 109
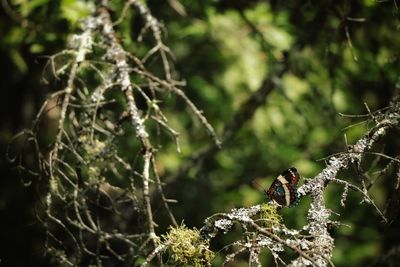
264, 167, 300, 208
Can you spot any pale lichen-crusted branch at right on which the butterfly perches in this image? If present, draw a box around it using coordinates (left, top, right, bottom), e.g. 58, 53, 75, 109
196, 99, 400, 266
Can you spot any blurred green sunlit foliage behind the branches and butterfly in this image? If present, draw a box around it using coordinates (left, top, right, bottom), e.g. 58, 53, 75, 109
0, 0, 400, 266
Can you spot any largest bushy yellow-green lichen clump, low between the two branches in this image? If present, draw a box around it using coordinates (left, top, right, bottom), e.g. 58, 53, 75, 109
163, 225, 214, 267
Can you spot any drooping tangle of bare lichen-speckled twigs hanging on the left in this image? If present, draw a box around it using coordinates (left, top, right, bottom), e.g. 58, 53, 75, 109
9, 0, 219, 266
